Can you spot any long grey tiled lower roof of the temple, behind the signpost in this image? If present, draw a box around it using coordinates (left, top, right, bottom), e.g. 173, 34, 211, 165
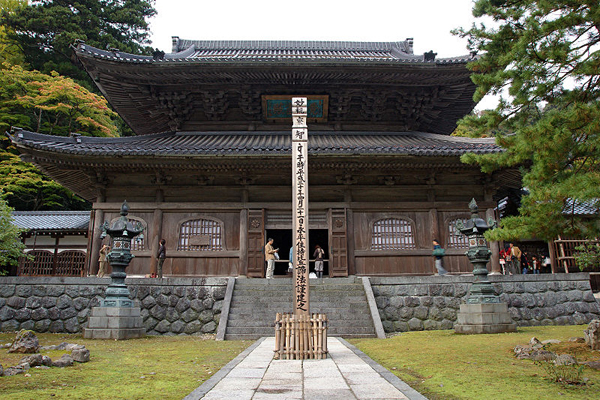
12, 130, 502, 157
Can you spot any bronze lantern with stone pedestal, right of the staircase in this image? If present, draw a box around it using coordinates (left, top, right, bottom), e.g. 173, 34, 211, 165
454, 199, 517, 333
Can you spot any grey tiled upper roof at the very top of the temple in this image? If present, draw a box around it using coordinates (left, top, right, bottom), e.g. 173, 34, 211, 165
76, 38, 472, 64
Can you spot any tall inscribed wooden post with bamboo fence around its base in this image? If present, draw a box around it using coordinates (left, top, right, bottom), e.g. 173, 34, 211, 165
275, 97, 327, 360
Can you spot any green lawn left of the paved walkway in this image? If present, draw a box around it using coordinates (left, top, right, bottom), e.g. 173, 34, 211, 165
0, 333, 252, 400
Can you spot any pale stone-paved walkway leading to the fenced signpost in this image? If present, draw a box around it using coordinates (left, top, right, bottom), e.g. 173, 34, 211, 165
184, 337, 426, 400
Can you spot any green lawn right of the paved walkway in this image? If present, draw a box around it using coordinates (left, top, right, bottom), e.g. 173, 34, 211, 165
351, 325, 600, 400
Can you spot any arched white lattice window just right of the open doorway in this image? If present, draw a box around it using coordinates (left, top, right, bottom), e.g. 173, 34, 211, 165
371, 218, 416, 250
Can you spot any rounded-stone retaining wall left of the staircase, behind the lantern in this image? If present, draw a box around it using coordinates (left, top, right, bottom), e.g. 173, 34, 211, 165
0, 277, 227, 335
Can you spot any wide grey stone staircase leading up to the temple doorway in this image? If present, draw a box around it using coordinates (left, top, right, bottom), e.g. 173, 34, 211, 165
225, 277, 376, 340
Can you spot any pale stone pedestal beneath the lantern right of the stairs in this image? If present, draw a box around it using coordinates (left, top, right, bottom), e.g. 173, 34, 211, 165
454, 303, 517, 334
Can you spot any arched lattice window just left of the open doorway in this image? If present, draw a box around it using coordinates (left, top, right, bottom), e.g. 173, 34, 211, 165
177, 218, 223, 251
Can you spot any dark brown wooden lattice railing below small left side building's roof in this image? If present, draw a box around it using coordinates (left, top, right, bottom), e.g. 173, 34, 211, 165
17, 250, 86, 276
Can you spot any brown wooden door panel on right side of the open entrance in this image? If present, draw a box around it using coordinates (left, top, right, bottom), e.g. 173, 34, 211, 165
329, 208, 348, 278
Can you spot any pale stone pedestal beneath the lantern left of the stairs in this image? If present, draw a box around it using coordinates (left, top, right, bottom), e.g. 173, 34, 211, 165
83, 307, 146, 340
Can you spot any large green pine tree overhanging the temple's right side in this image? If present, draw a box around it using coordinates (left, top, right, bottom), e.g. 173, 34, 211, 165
455, 0, 600, 240
